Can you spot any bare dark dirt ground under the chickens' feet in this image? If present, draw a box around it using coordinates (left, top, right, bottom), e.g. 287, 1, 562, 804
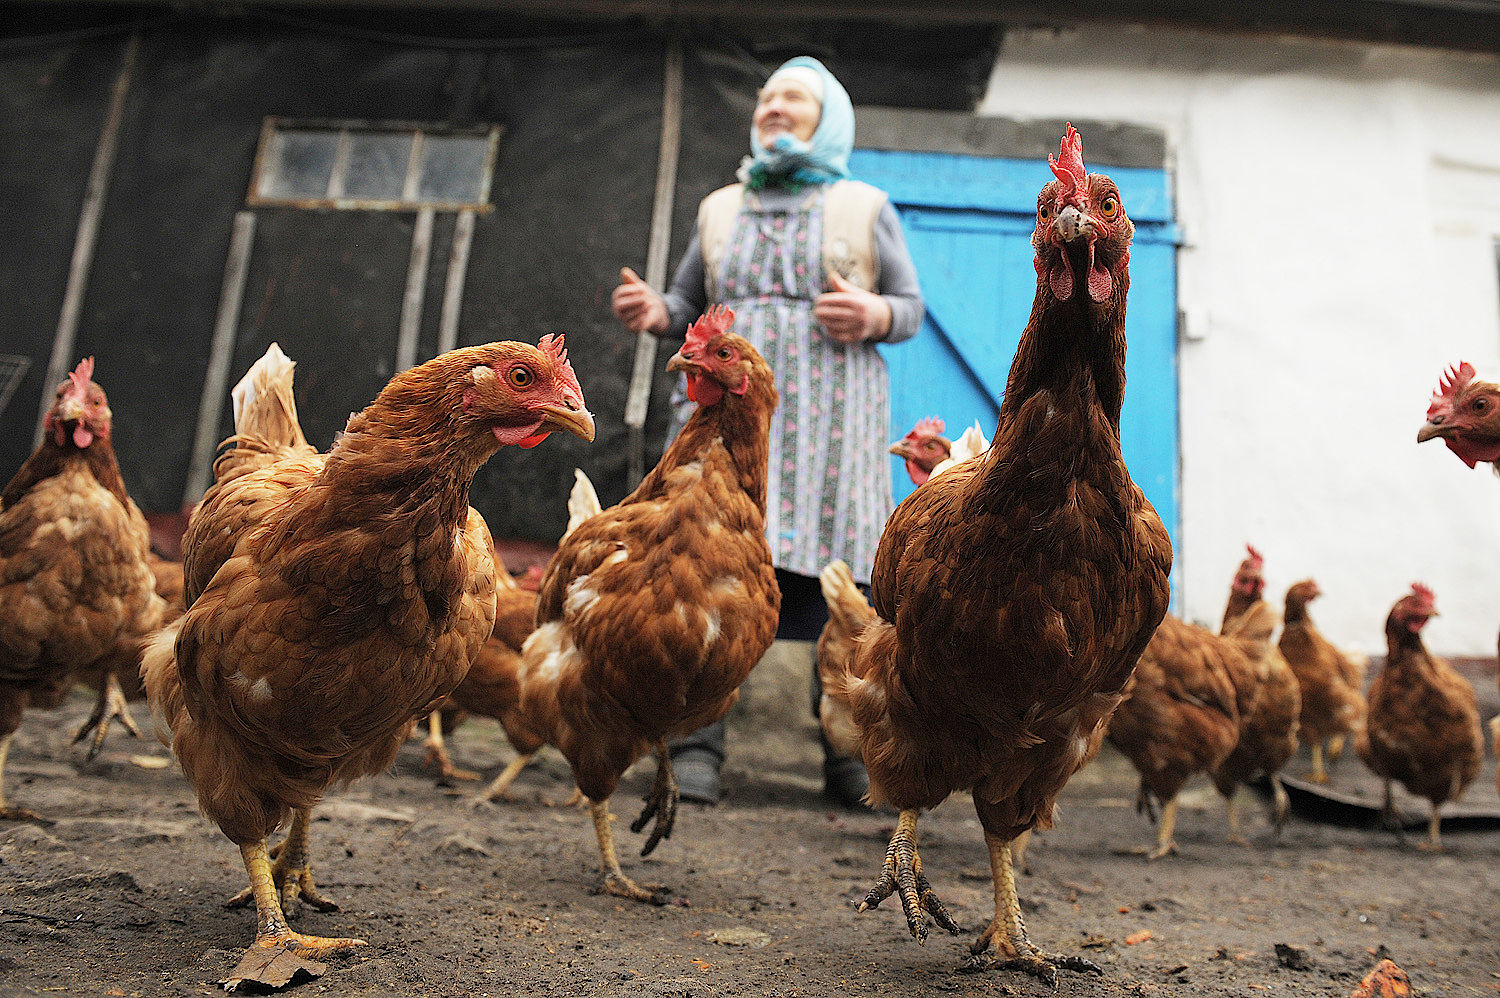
0, 642, 1500, 998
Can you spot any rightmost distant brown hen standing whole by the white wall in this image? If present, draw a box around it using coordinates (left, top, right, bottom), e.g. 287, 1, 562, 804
1355, 584, 1485, 851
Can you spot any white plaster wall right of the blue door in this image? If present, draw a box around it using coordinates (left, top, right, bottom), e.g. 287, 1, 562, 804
978, 26, 1500, 656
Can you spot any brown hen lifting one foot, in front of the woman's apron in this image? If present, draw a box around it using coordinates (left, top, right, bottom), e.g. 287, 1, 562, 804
507, 306, 782, 903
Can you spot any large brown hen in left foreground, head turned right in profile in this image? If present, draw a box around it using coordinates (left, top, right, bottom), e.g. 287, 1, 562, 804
143, 336, 594, 981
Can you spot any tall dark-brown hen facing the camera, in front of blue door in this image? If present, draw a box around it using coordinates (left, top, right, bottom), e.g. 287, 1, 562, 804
831, 126, 1172, 981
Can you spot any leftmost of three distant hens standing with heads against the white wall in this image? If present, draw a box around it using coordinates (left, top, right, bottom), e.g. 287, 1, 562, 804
1212, 545, 1302, 845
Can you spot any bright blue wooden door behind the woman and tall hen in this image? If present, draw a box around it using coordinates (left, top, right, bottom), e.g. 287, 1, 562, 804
851, 149, 1179, 546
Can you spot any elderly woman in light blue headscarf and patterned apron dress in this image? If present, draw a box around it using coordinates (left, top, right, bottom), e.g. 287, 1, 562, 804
612, 56, 923, 806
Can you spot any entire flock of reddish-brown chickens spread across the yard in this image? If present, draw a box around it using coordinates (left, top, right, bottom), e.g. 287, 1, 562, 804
0, 126, 1500, 986
